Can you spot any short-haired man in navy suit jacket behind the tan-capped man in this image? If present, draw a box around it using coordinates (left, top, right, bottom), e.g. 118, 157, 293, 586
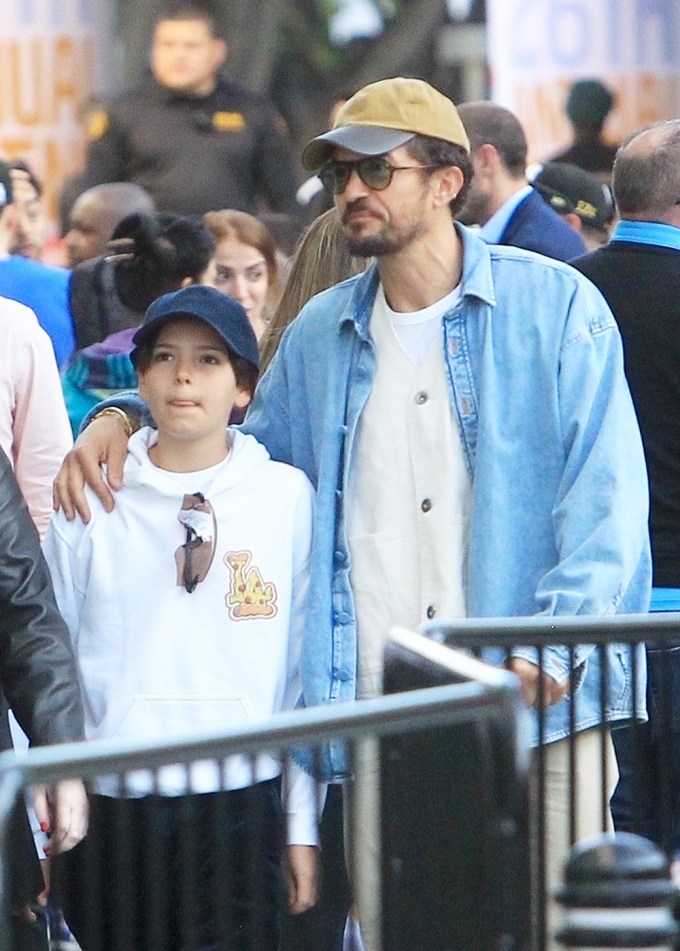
458, 102, 585, 261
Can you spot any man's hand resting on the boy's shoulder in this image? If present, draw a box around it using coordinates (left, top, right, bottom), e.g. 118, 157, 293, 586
52, 416, 127, 522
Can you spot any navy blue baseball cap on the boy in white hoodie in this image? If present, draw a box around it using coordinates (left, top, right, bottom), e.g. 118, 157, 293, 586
130, 284, 260, 370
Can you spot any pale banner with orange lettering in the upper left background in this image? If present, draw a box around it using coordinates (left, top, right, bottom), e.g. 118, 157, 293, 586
0, 0, 116, 224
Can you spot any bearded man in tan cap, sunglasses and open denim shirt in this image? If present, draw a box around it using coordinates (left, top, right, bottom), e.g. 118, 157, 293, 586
55, 78, 649, 951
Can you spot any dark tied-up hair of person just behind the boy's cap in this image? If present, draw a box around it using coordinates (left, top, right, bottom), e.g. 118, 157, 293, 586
108, 214, 215, 314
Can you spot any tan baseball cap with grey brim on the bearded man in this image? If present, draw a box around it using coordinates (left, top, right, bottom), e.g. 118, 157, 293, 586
302, 77, 470, 171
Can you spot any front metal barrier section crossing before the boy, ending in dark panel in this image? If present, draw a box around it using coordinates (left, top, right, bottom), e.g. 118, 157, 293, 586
0, 633, 529, 951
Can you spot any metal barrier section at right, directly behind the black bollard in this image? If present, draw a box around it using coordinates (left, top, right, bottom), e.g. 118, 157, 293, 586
424, 612, 680, 951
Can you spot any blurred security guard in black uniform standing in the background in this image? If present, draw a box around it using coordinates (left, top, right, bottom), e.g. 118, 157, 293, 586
68, 6, 299, 215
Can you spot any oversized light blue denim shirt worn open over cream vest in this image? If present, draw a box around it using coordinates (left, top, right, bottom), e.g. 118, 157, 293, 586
243, 227, 651, 779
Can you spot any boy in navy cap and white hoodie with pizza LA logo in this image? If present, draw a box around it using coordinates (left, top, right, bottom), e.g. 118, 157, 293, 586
45, 286, 317, 949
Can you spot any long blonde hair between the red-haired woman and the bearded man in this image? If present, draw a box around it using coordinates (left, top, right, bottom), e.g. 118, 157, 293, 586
260, 208, 370, 374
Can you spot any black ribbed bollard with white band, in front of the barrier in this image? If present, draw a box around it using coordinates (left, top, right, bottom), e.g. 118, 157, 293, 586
555, 832, 679, 951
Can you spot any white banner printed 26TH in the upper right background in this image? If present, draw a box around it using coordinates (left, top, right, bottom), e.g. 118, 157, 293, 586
486, 0, 680, 159
